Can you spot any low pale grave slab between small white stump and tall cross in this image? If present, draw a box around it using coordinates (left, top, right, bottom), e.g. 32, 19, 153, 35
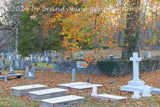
97, 94, 127, 101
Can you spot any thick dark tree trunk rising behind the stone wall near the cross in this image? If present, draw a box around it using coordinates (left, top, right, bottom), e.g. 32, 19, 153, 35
122, 0, 140, 60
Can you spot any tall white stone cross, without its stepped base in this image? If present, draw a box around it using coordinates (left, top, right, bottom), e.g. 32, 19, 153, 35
130, 52, 142, 81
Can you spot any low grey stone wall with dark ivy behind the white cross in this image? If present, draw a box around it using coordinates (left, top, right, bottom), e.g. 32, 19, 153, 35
53, 60, 159, 76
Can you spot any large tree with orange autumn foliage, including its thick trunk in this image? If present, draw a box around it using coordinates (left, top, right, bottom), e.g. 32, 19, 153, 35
20, 0, 158, 60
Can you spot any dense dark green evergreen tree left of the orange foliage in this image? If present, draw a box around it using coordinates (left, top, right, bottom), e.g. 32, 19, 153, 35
18, 11, 63, 56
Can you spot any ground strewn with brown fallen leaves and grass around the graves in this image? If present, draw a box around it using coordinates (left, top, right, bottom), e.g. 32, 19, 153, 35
0, 70, 160, 107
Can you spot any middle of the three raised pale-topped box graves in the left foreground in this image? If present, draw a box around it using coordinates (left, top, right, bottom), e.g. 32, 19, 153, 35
29, 88, 67, 101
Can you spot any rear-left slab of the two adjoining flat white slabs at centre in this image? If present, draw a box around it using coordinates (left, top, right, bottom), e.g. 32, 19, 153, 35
59, 82, 90, 88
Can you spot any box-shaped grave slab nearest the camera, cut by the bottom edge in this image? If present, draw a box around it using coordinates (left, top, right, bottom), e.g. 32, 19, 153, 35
41, 95, 84, 107
